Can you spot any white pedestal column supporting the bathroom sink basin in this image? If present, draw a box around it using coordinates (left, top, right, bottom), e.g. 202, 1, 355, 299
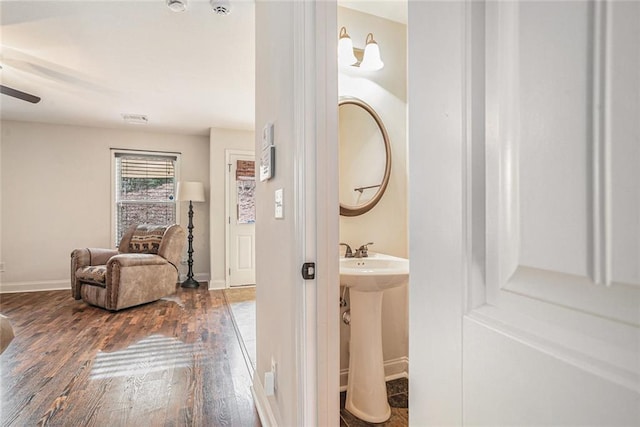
345, 288, 391, 423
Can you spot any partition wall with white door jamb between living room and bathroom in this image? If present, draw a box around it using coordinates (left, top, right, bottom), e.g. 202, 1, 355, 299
253, 1, 339, 426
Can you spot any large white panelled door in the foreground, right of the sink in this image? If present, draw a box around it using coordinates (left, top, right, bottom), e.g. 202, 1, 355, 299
408, 1, 640, 425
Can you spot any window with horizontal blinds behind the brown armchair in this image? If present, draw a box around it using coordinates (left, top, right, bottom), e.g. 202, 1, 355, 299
112, 150, 178, 245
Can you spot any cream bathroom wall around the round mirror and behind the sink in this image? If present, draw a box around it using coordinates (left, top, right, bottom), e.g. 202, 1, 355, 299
338, 7, 409, 386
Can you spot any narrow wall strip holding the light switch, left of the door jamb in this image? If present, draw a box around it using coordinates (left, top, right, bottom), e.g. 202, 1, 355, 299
254, 2, 302, 426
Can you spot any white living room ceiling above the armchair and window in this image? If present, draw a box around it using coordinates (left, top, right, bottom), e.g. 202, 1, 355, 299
0, 0, 255, 135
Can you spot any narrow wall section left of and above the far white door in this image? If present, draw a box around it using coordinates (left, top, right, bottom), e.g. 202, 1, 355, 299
209, 128, 255, 288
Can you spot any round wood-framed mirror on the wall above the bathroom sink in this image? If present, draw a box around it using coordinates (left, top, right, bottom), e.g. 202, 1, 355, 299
338, 98, 391, 216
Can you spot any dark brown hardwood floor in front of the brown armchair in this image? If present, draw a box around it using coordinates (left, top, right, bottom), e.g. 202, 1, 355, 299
0, 287, 260, 427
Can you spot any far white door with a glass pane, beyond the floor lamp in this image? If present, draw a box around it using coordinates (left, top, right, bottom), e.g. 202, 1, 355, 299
226, 151, 256, 286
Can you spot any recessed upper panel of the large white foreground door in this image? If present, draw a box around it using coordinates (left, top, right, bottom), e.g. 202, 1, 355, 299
486, 2, 640, 330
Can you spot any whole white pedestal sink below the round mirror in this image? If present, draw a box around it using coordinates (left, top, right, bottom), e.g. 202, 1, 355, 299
340, 253, 409, 423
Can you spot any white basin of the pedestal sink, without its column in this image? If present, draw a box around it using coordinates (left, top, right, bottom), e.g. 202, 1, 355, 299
340, 253, 409, 292
